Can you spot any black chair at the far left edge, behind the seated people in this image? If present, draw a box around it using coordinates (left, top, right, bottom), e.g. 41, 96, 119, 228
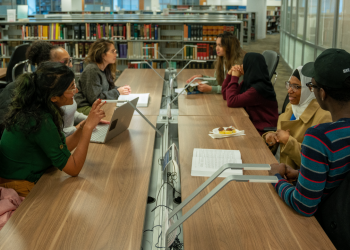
0, 43, 30, 87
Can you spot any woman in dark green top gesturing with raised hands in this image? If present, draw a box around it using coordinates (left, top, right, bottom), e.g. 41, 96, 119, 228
0, 62, 105, 197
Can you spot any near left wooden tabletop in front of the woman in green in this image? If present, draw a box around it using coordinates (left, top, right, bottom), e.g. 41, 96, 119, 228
0, 104, 157, 250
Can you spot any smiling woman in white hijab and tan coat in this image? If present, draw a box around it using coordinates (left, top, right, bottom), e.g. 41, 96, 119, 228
263, 66, 332, 169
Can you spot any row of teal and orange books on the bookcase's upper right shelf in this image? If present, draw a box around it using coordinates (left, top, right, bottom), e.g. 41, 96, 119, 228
183, 24, 239, 41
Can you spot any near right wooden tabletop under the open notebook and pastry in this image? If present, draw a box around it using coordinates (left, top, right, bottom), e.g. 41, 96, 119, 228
178, 116, 335, 250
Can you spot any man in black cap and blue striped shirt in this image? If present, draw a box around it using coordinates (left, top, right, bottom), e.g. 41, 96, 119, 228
270, 49, 350, 216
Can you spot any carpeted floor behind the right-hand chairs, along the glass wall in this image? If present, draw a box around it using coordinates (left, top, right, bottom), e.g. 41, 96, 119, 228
243, 34, 292, 112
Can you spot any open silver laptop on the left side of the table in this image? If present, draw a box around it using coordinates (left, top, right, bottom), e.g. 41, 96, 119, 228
90, 97, 139, 143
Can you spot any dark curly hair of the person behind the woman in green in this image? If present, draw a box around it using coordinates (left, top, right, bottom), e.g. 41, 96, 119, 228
26, 41, 59, 65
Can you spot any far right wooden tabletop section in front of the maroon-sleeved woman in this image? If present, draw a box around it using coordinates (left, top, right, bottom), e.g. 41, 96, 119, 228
177, 69, 248, 116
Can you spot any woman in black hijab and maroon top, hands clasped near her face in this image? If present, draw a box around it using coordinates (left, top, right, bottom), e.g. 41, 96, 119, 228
222, 53, 278, 134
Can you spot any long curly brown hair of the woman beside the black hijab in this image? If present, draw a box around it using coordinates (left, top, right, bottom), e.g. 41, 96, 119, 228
215, 31, 246, 85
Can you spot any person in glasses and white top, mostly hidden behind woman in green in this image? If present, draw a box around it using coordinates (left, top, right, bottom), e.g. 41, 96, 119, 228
0, 41, 94, 137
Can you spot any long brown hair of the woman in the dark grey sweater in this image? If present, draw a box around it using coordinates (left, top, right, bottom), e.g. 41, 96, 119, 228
85, 39, 117, 89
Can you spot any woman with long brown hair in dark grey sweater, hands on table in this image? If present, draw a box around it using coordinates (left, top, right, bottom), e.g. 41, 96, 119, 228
74, 39, 131, 115
